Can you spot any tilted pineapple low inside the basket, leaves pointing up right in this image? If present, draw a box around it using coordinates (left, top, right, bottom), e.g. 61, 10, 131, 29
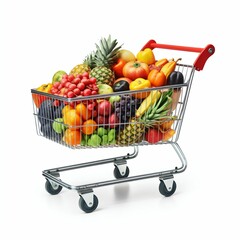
117, 90, 173, 146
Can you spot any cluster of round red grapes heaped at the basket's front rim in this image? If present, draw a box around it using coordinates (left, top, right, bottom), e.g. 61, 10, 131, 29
51, 72, 98, 98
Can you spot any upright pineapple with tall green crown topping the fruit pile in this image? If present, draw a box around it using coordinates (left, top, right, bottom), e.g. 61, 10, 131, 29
90, 35, 121, 86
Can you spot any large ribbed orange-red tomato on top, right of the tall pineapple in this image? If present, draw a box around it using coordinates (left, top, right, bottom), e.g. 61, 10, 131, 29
123, 61, 150, 80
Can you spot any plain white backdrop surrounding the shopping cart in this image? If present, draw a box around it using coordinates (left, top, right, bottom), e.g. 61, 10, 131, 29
0, 0, 240, 240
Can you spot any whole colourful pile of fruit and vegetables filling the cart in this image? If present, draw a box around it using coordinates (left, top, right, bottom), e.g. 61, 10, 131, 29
32, 36, 184, 147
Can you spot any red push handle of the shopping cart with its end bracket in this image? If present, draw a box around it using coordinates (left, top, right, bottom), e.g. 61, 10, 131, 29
141, 40, 215, 71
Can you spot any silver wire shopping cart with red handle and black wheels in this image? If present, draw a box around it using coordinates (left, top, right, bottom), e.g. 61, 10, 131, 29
31, 40, 215, 213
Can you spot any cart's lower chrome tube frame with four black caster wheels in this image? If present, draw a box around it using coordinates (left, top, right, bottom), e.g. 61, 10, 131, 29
42, 142, 187, 213
